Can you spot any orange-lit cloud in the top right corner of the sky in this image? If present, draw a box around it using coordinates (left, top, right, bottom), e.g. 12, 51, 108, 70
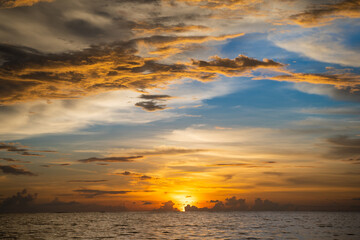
290, 0, 360, 27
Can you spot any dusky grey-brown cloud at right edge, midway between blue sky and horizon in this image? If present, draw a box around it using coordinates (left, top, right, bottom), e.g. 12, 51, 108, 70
326, 135, 360, 159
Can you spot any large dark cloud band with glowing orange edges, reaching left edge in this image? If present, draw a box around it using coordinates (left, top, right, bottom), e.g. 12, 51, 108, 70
0, 37, 264, 105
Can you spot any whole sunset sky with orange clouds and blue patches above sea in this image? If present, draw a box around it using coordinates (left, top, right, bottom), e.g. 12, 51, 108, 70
0, 0, 360, 211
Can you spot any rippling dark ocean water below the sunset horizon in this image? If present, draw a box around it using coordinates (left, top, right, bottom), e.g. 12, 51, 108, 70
0, 212, 360, 240
